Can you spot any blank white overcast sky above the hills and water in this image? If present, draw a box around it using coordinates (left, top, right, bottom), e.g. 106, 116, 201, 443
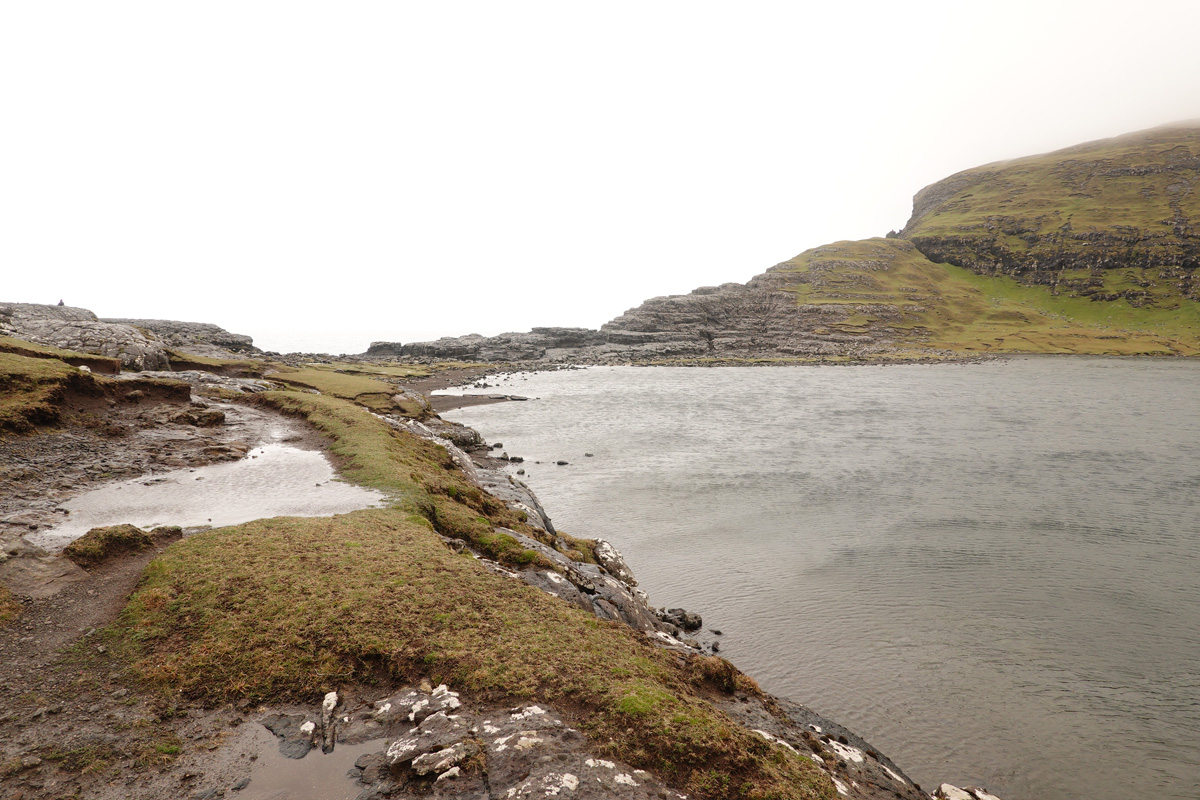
0, 0, 1200, 349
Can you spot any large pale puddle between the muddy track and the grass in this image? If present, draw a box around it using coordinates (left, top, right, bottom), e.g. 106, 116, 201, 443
25, 443, 384, 549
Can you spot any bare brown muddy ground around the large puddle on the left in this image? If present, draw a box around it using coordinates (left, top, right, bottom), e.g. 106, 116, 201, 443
0, 389, 338, 800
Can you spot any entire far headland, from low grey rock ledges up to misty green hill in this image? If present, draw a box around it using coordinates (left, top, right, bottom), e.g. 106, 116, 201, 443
388, 122, 1200, 363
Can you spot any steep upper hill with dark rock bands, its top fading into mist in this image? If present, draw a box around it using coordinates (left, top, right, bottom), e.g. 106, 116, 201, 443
901, 122, 1200, 308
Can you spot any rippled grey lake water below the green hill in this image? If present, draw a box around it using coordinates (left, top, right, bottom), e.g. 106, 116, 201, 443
445, 357, 1200, 800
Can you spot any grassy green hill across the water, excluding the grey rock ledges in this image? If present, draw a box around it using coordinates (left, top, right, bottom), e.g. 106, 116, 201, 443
750, 122, 1200, 355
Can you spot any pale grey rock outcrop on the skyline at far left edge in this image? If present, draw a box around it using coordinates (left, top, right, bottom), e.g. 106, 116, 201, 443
0, 302, 170, 369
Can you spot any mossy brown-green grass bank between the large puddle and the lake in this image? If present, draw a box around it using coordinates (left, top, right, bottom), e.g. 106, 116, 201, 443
112, 392, 836, 799
